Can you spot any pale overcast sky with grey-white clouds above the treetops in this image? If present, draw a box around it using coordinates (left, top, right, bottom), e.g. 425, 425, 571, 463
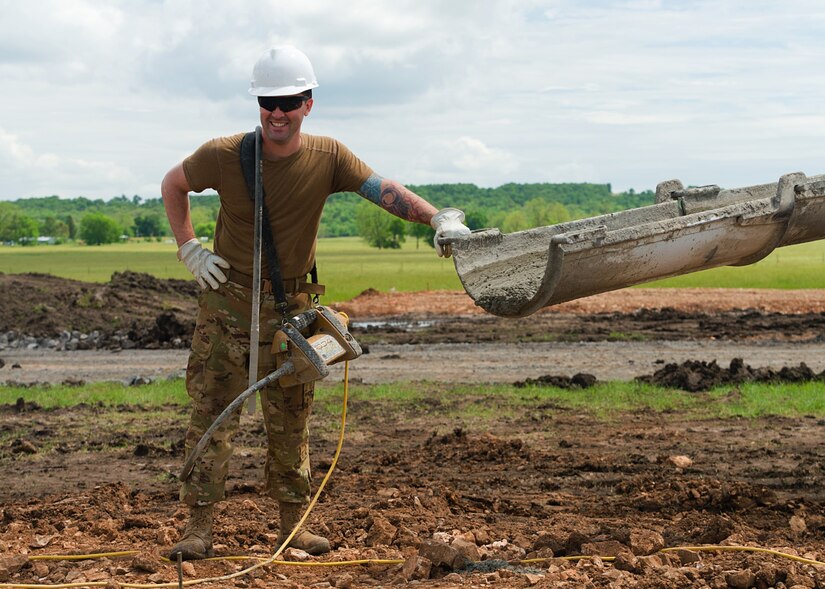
0, 0, 825, 200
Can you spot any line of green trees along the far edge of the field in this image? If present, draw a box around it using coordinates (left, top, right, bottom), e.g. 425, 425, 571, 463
0, 183, 654, 248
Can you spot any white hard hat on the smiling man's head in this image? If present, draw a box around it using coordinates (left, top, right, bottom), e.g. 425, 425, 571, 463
249, 45, 318, 96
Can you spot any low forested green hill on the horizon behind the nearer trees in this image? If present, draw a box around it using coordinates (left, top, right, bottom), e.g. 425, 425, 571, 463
0, 183, 654, 241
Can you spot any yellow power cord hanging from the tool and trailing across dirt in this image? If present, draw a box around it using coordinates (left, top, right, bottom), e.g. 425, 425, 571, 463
0, 352, 825, 589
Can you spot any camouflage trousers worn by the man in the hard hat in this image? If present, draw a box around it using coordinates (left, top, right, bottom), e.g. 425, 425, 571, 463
180, 282, 314, 506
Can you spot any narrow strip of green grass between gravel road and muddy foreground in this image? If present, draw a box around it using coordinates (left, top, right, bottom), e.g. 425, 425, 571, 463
0, 379, 825, 421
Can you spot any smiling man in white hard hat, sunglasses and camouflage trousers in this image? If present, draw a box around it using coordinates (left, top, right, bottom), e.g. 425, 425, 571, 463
161, 46, 469, 559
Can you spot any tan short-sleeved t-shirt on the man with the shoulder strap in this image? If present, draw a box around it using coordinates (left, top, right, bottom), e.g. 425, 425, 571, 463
183, 133, 372, 279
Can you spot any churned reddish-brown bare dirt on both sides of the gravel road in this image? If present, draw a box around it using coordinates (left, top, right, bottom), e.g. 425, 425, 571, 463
0, 275, 825, 588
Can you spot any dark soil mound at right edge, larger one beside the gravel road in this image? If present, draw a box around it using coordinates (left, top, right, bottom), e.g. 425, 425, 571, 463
636, 358, 825, 392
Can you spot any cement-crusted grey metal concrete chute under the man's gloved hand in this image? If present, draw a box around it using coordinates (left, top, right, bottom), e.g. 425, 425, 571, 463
452, 173, 825, 317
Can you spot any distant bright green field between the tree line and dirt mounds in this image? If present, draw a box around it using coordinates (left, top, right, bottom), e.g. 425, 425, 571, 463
0, 237, 825, 303
